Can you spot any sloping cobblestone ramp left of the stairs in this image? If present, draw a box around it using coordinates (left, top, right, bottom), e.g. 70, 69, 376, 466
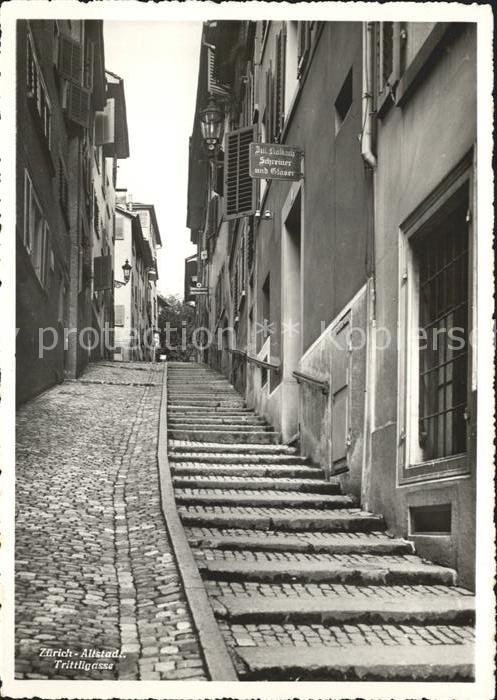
16, 362, 206, 680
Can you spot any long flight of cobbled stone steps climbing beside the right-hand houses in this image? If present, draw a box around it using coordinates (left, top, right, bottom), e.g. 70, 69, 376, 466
168, 363, 474, 681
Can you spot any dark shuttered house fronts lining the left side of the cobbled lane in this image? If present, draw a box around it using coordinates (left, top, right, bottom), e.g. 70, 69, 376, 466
16, 20, 129, 402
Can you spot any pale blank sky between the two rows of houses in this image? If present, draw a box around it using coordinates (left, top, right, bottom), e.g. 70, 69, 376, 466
104, 20, 202, 297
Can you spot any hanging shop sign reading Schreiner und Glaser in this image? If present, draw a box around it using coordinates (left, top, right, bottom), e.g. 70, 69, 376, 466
249, 143, 303, 180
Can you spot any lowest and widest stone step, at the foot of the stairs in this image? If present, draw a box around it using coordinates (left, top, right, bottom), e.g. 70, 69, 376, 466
236, 643, 474, 682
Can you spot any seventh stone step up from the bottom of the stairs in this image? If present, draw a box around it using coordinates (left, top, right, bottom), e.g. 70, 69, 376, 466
173, 476, 340, 494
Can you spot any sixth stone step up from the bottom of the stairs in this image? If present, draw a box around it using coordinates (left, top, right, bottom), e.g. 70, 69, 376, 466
176, 488, 357, 510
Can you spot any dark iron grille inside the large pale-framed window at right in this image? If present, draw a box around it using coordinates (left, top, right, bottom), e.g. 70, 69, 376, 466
414, 201, 468, 461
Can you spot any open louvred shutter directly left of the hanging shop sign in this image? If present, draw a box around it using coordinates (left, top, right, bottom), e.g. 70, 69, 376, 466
224, 126, 256, 221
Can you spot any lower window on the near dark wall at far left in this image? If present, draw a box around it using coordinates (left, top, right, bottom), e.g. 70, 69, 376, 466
23, 170, 50, 287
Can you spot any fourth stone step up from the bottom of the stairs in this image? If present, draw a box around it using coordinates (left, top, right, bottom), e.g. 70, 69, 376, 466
188, 528, 414, 555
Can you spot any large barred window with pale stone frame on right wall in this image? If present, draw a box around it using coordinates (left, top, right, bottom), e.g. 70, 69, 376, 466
398, 165, 475, 483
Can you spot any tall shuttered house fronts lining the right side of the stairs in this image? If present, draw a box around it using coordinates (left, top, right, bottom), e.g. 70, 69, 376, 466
185, 21, 476, 585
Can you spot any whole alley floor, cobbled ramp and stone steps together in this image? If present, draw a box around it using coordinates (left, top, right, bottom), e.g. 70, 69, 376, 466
16, 362, 475, 681
